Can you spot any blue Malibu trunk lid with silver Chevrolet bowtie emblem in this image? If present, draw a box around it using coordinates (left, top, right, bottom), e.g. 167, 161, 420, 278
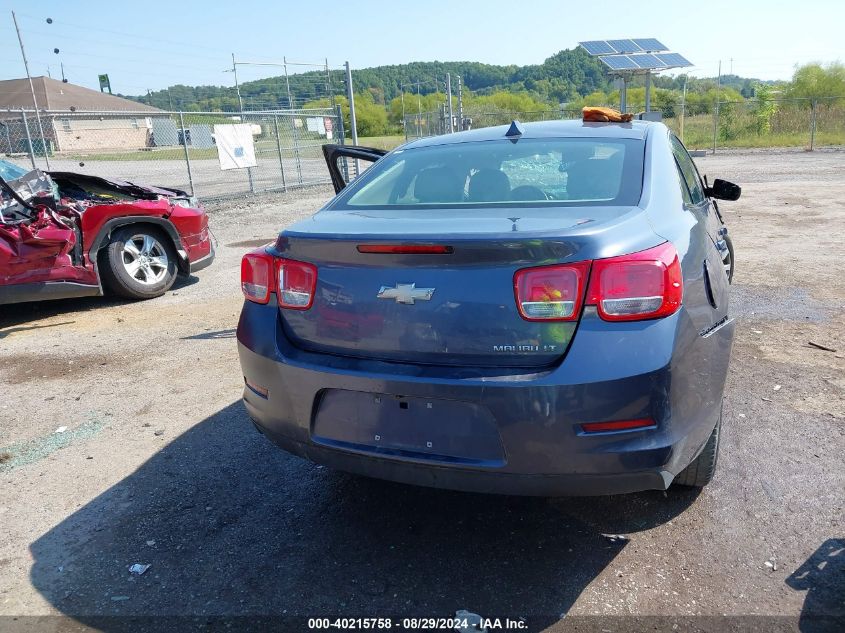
274, 207, 659, 367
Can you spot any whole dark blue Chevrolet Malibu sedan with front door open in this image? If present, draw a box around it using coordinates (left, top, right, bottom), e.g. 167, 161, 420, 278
237, 121, 740, 495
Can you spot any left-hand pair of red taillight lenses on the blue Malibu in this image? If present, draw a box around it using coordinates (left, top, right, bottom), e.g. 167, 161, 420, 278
241, 249, 317, 310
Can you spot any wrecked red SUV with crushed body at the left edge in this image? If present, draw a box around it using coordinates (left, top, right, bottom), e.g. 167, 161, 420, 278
0, 160, 214, 305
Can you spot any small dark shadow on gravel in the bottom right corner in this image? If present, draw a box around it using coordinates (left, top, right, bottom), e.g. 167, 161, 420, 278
785, 538, 845, 633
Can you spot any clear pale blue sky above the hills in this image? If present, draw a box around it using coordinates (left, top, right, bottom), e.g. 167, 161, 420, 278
0, 0, 845, 95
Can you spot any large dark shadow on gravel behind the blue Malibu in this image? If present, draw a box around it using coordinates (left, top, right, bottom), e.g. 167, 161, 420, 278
31, 402, 697, 622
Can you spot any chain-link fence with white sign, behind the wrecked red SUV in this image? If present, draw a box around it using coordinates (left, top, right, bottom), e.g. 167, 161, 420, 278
0, 108, 344, 199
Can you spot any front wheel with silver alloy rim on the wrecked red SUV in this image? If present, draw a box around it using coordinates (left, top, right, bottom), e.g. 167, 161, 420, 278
99, 225, 177, 299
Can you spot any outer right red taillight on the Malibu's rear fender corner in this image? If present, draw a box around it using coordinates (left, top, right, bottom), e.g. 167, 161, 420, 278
587, 242, 684, 321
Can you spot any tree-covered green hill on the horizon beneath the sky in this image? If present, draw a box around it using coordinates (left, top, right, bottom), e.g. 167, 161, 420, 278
121, 48, 772, 112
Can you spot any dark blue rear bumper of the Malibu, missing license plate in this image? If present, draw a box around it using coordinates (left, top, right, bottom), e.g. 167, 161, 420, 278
238, 304, 733, 495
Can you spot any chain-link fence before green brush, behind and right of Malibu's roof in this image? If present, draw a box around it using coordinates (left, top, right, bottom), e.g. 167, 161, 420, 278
404, 98, 845, 152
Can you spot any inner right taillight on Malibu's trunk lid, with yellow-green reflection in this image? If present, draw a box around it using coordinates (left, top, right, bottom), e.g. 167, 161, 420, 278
513, 261, 590, 321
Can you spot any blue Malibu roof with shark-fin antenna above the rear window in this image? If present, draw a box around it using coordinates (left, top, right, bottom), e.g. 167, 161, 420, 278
403, 119, 663, 149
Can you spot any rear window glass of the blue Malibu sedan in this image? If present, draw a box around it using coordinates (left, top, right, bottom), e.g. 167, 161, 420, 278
329, 138, 644, 209
